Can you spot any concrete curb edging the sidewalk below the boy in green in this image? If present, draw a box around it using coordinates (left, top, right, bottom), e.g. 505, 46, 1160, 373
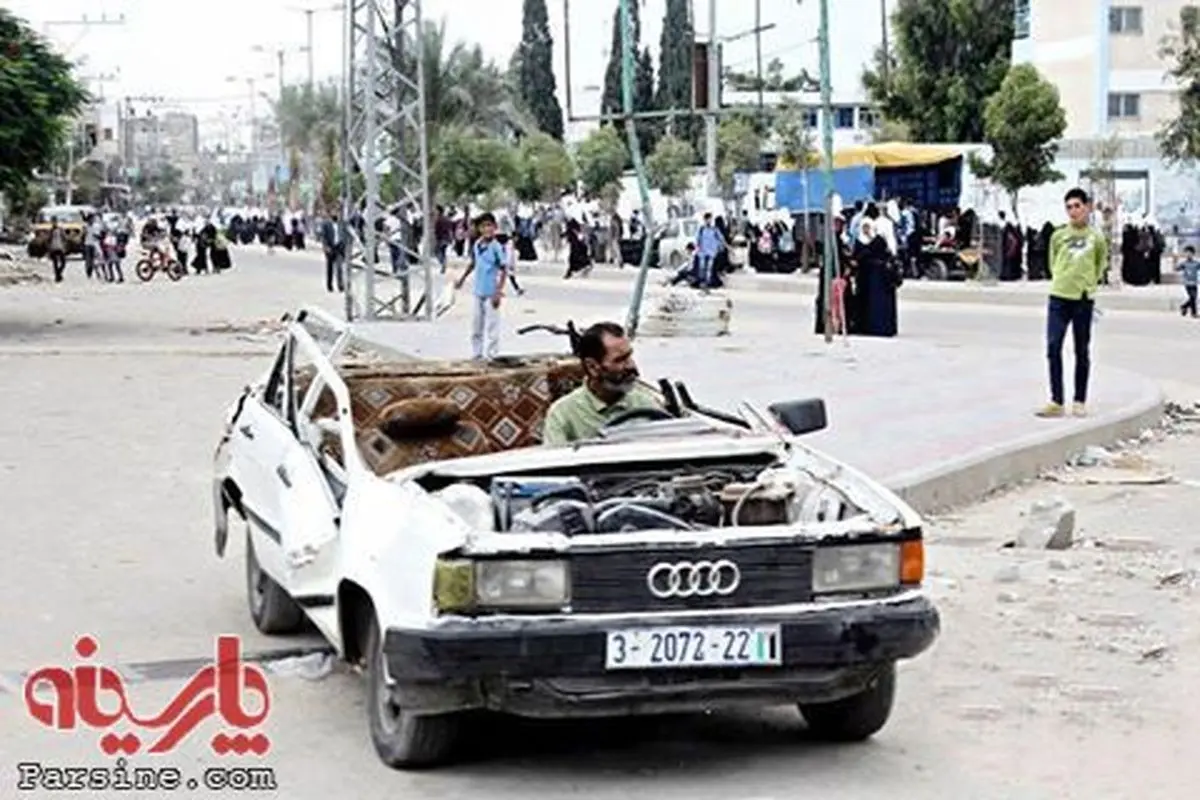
886, 373, 1166, 515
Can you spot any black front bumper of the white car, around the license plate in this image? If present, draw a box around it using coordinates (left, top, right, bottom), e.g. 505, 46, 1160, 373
384, 595, 941, 717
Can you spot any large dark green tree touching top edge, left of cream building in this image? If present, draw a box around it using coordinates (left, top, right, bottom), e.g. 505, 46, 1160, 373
863, 0, 1014, 143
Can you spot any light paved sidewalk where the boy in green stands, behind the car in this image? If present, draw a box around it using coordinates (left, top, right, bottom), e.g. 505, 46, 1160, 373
358, 289, 1162, 511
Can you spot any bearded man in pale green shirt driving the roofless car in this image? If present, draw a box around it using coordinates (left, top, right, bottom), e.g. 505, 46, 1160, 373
542, 323, 662, 445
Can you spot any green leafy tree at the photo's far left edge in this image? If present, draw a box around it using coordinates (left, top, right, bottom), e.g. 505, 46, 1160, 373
0, 8, 89, 198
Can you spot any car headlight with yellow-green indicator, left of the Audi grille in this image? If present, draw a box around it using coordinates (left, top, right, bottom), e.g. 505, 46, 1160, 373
433, 559, 571, 612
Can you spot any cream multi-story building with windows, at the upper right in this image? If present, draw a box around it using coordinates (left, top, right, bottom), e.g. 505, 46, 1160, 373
1013, 0, 1196, 139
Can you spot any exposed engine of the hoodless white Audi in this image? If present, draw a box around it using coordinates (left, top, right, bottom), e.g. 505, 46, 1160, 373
458, 467, 860, 536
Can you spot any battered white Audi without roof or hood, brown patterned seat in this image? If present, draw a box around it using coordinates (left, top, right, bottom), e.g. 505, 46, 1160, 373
214, 311, 940, 768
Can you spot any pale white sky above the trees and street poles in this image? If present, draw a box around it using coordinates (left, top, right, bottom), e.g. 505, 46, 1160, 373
7, 0, 894, 137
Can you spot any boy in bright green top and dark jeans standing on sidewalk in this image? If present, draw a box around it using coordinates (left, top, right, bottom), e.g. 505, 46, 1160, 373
1038, 188, 1109, 417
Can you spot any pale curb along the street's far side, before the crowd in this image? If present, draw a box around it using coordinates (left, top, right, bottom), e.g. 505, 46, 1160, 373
252, 245, 1183, 313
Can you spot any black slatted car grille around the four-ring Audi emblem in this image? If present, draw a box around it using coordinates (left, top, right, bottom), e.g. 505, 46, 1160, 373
571, 545, 812, 614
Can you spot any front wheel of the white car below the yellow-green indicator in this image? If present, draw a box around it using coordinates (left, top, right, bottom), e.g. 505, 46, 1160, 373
362, 609, 462, 769
